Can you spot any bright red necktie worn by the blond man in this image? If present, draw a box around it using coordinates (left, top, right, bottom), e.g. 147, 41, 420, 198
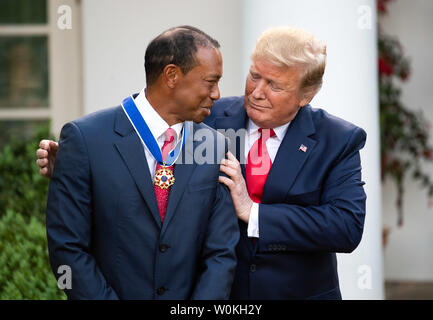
245, 128, 275, 203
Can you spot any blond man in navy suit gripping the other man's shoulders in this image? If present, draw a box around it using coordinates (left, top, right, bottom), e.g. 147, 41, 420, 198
37, 27, 366, 299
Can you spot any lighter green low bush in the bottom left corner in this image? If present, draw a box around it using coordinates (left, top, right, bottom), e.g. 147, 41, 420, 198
0, 210, 65, 299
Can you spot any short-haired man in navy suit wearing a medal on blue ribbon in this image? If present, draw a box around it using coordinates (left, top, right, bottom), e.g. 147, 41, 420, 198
46, 26, 239, 299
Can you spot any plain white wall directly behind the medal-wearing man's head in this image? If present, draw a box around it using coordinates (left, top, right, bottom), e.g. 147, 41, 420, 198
82, 0, 243, 114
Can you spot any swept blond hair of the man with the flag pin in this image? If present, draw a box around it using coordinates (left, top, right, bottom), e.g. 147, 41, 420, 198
251, 26, 326, 96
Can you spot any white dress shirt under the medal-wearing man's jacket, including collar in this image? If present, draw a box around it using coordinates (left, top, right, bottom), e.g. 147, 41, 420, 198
134, 88, 183, 183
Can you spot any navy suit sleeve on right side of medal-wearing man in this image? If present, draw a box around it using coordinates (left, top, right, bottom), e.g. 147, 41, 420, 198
191, 136, 239, 300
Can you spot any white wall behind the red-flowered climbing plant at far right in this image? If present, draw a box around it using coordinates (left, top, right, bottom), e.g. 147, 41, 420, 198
382, 0, 433, 282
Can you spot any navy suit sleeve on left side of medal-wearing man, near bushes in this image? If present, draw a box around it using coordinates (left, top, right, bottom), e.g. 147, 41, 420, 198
46, 122, 118, 299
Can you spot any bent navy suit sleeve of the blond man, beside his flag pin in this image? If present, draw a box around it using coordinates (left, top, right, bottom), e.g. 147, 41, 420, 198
259, 128, 366, 253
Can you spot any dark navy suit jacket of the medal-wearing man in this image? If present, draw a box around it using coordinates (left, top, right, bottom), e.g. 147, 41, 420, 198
46, 107, 239, 299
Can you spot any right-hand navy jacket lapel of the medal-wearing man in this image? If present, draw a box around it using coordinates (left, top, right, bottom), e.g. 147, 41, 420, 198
161, 121, 197, 234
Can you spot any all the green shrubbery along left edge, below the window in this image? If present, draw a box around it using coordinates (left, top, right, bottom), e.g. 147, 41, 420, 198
0, 127, 65, 299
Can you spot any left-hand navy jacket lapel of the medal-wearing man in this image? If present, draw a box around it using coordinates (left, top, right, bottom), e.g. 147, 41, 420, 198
114, 108, 161, 228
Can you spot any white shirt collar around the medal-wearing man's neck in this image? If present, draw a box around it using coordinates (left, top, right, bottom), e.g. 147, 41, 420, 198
134, 88, 183, 142
